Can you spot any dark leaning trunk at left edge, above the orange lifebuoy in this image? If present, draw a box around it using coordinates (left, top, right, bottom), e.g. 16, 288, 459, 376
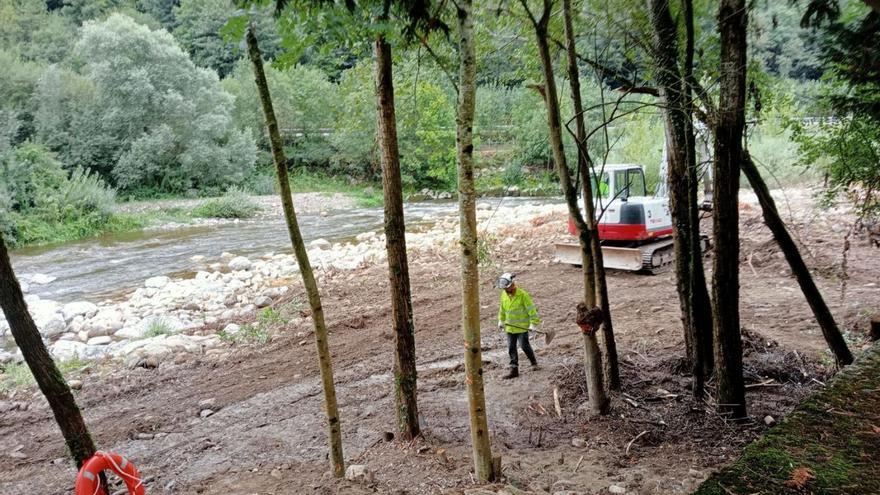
0, 235, 96, 468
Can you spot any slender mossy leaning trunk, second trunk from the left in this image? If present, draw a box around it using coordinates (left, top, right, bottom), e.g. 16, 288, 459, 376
246, 24, 345, 477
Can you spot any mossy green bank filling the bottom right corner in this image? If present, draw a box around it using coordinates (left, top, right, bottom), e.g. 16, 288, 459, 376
695, 345, 880, 495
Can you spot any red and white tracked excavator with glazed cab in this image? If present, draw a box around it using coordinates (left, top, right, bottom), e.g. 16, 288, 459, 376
556, 164, 675, 273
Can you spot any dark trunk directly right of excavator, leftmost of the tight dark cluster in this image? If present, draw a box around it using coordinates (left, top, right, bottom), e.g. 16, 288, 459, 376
648, 0, 711, 396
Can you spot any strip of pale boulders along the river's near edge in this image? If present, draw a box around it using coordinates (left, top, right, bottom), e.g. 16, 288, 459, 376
0, 203, 564, 367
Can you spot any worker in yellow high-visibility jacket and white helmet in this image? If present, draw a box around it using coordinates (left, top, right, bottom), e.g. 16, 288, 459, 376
495, 273, 541, 380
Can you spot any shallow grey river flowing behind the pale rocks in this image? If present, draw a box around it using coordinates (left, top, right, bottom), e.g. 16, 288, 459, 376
12, 198, 559, 302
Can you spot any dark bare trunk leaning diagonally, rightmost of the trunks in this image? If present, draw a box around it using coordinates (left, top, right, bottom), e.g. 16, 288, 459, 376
742, 150, 853, 366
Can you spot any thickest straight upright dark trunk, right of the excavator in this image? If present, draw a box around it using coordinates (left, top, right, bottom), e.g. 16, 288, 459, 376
712, 0, 748, 418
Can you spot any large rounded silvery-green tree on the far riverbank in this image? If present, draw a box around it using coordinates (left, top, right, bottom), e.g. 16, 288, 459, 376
76, 14, 256, 192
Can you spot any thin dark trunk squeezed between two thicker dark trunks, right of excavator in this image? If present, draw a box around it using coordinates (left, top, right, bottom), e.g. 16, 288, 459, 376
682, 0, 715, 388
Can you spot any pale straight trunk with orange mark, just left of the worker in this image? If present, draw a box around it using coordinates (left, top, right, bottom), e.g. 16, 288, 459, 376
455, 0, 501, 481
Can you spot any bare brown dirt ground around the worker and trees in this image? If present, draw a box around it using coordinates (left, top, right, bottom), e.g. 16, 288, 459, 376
0, 192, 880, 495
